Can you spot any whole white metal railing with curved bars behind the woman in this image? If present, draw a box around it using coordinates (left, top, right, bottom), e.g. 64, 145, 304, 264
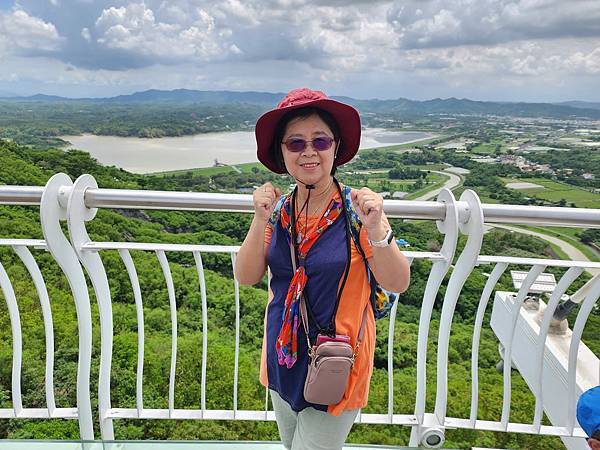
0, 174, 600, 445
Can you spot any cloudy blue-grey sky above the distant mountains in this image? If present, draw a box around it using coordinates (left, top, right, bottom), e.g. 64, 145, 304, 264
0, 0, 600, 102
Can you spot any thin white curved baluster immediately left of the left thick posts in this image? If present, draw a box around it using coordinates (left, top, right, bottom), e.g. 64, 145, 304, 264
12, 245, 56, 417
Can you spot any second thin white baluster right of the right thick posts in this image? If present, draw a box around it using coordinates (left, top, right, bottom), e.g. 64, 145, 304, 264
500, 264, 546, 430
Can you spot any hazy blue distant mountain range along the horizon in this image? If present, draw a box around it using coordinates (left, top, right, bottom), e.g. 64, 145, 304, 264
0, 89, 600, 119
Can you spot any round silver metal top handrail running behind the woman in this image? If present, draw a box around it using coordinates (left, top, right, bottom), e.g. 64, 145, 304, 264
0, 185, 600, 228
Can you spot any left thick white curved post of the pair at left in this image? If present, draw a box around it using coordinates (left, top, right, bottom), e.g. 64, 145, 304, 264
40, 173, 94, 440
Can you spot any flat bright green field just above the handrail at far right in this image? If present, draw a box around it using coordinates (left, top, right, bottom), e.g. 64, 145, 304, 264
502, 178, 600, 208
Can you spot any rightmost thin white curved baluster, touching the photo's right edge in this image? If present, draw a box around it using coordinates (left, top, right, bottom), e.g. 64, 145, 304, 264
567, 277, 600, 434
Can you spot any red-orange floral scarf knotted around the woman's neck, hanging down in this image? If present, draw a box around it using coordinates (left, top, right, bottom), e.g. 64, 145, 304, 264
275, 195, 343, 369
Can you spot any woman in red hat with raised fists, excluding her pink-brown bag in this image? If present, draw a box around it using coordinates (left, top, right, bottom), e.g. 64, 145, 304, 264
235, 89, 410, 450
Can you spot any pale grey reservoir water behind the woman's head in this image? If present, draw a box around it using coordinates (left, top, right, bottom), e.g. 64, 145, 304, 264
61, 128, 434, 173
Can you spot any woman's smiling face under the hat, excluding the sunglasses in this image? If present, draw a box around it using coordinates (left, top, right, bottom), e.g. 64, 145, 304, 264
281, 115, 336, 184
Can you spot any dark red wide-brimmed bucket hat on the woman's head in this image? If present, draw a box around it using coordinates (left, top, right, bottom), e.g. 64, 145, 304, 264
254, 88, 360, 173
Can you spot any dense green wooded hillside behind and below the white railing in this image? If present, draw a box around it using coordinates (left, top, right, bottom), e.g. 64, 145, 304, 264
0, 140, 600, 449
